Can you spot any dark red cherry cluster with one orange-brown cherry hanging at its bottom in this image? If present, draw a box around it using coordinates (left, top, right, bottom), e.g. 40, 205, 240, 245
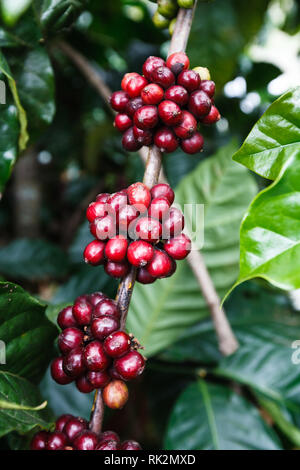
51, 292, 145, 409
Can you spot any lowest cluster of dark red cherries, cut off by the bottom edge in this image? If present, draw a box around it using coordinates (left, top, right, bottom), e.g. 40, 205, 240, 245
30, 414, 141, 450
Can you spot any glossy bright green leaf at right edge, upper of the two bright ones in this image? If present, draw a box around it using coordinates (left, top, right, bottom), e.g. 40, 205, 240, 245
233, 87, 300, 180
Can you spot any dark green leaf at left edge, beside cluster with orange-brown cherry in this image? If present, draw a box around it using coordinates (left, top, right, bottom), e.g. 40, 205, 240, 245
0, 282, 57, 380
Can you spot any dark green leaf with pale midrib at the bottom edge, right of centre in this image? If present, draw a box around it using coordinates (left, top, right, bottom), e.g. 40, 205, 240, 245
165, 380, 282, 450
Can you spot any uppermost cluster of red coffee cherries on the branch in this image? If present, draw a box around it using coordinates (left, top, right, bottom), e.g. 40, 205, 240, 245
110, 52, 220, 154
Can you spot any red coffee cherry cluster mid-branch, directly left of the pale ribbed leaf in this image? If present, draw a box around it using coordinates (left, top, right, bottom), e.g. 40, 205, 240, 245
84, 183, 191, 284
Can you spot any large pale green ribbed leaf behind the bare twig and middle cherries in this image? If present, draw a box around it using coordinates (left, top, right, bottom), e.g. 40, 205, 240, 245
127, 144, 256, 356
